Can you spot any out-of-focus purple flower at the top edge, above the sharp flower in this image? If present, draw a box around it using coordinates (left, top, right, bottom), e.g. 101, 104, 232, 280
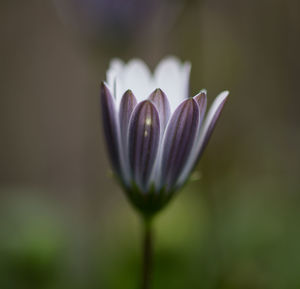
54, 0, 181, 45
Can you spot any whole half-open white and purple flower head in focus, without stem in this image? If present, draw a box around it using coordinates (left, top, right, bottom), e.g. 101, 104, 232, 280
101, 57, 229, 215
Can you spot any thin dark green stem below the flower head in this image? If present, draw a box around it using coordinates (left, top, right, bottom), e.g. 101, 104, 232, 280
141, 220, 153, 289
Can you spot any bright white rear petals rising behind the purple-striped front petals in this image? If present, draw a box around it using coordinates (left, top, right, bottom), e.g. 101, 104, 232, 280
106, 56, 191, 111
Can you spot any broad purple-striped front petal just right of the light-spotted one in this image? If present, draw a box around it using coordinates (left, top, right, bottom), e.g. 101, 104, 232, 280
161, 98, 200, 189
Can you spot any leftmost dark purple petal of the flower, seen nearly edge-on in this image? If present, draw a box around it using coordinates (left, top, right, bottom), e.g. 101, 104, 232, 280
100, 83, 121, 175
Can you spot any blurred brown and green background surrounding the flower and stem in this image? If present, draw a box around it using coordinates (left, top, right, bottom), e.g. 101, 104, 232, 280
0, 0, 300, 289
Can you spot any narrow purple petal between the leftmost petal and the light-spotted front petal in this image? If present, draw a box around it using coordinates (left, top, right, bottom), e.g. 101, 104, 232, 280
119, 90, 137, 146
